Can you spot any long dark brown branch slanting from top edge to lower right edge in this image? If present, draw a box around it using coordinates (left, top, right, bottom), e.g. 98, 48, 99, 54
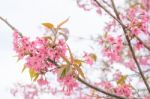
111, 0, 150, 93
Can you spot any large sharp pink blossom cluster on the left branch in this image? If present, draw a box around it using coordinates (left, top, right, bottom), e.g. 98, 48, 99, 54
13, 32, 67, 73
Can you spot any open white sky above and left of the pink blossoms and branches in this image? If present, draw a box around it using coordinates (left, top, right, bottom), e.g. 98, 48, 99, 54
0, 0, 103, 99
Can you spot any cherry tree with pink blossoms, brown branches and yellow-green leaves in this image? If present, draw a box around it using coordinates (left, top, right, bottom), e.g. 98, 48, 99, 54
0, 0, 150, 99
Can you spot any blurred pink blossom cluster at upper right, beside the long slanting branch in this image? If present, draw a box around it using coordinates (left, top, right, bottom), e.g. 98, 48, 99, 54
127, 6, 149, 35
